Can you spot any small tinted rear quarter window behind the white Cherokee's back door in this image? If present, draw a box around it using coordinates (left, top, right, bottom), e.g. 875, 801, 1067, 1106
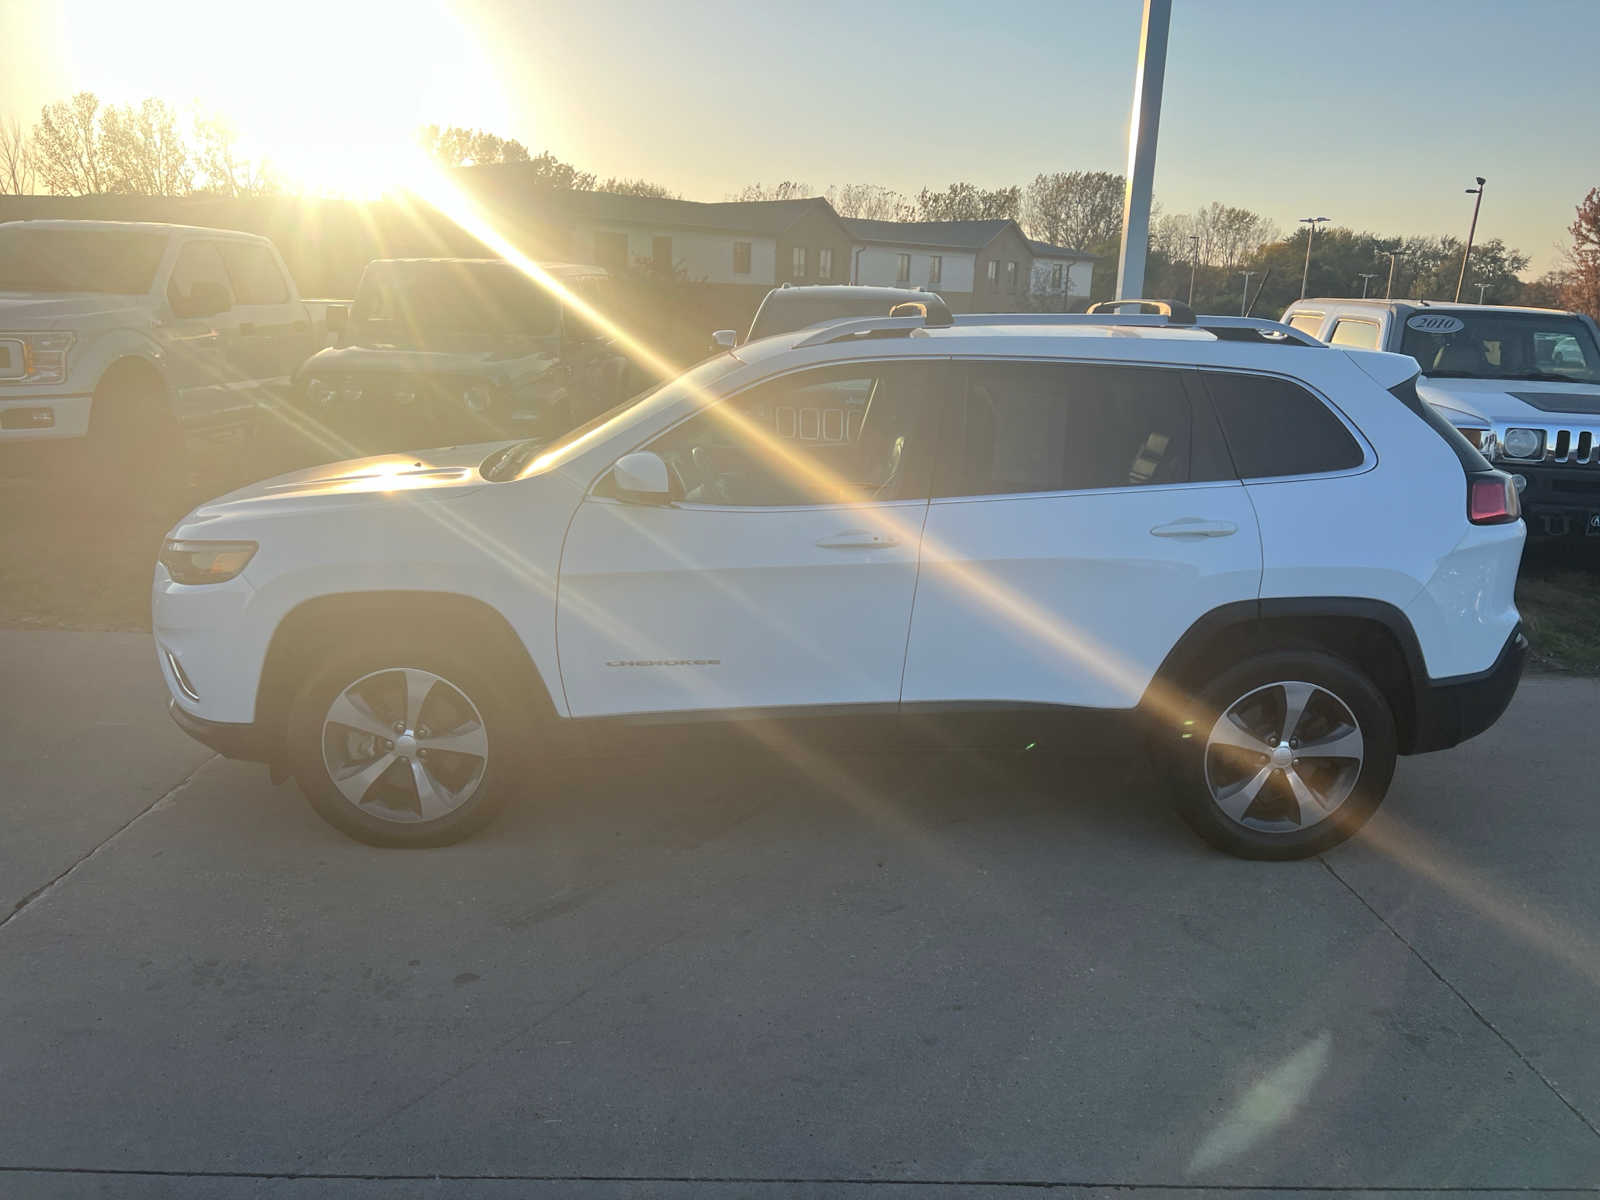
1203, 371, 1363, 478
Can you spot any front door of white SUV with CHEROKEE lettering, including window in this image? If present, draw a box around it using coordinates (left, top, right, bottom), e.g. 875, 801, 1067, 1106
557, 362, 946, 717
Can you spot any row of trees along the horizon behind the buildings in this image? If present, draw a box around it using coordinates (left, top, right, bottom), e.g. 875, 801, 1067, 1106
0, 91, 1600, 317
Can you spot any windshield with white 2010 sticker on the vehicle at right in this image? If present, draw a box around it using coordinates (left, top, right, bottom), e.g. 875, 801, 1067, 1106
1400, 309, 1600, 384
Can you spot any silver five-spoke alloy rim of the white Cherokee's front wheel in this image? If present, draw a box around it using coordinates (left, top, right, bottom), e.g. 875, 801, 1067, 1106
322, 667, 490, 824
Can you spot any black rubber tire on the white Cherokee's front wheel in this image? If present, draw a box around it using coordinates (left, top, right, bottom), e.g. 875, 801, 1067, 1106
286, 634, 534, 846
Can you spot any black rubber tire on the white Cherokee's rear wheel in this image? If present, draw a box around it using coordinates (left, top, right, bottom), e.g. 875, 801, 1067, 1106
1168, 650, 1398, 859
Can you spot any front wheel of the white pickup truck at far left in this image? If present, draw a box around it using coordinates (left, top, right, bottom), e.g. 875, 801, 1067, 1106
83, 368, 189, 504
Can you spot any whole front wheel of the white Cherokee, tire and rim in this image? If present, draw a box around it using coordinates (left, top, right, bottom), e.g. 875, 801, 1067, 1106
288, 638, 518, 846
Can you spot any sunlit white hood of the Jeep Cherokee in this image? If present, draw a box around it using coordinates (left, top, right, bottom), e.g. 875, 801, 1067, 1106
179, 442, 506, 536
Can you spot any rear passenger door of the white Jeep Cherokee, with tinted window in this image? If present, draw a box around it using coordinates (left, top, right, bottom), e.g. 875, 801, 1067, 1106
902, 360, 1261, 712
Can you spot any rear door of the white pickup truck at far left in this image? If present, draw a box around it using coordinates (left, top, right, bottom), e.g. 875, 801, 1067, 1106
219, 240, 314, 403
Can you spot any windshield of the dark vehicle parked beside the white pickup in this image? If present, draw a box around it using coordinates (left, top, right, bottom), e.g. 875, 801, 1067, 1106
350, 262, 562, 338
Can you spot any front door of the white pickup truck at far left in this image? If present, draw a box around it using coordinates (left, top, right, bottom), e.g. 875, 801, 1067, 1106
160, 242, 240, 427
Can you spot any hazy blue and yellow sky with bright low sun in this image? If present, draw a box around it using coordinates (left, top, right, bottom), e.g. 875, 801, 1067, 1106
0, 0, 1600, 274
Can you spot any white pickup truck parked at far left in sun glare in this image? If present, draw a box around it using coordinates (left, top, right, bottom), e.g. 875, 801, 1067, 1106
0, 221, 325, 483
